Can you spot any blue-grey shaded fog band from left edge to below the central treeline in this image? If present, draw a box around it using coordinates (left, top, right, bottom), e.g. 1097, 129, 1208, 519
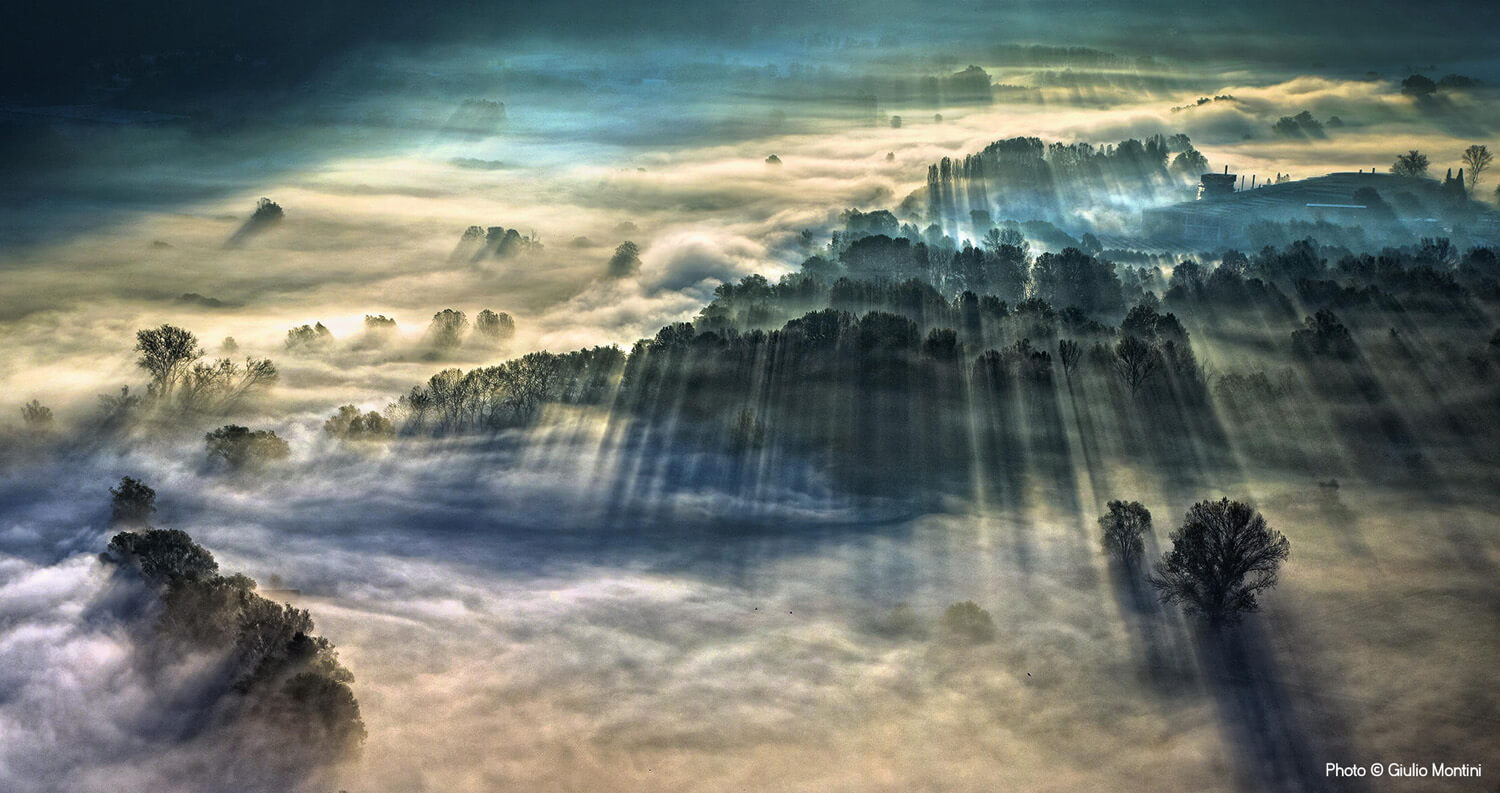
0, 419, 923, 594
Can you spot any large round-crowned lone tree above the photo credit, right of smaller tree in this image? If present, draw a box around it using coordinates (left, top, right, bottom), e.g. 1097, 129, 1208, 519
1151, 498, 1292, 625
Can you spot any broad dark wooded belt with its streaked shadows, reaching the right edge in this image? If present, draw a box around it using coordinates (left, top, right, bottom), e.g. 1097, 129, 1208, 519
366, 221, 1500, 501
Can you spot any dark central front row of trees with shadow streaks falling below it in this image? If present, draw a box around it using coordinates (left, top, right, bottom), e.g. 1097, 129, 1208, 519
617, 285, 1212, 501
